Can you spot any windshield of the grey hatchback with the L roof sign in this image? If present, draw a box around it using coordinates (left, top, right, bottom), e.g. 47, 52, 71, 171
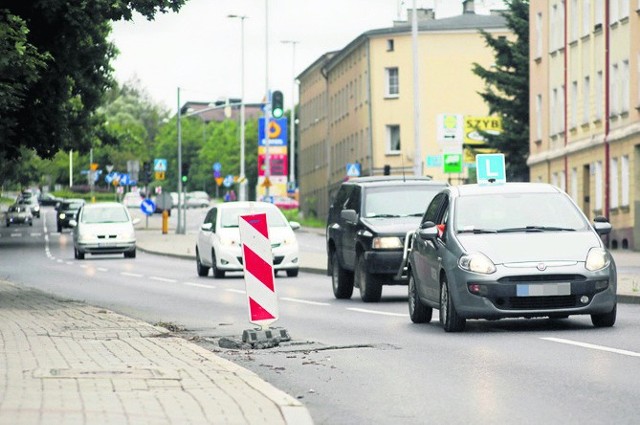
454, 193, 588, 233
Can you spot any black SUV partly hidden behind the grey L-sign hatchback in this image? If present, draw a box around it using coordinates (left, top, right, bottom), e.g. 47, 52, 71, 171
326, 176, 447, 302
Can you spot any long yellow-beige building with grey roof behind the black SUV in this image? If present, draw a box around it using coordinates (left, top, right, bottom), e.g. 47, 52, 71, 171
297, 0, 510, 222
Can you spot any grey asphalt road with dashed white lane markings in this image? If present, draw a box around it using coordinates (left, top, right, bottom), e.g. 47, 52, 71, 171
0, 208, 640, 424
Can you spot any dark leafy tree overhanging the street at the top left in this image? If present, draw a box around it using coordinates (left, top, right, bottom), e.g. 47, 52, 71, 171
0, 0, 186, 164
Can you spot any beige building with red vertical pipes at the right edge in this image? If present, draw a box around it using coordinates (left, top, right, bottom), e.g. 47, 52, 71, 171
528, 0, 640, 250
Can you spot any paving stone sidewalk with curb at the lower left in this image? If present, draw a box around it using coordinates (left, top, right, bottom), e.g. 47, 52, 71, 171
0, 281, 312, 425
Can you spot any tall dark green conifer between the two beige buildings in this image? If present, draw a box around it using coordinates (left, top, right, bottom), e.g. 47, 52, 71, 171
473, 0, 529, 181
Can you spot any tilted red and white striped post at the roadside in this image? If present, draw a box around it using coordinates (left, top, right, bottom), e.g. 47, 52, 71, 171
238, 213, 278, 329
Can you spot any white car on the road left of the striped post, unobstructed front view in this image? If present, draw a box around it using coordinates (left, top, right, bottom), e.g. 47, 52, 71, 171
69, 202, 140, 260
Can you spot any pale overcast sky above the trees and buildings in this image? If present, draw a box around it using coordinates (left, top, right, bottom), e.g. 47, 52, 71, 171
110, 0, 502, 110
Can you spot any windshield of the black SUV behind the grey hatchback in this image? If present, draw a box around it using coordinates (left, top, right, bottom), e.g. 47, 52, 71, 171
363, 185, 442, 218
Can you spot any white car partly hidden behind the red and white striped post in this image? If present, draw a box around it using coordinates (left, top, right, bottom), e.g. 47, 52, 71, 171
196, 202, 300, 278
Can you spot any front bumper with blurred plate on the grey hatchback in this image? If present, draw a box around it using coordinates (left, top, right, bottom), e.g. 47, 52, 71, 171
448, 263, 617, 319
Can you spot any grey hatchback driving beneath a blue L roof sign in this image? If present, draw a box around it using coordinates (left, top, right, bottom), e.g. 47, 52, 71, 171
407, 183, 617, 332
